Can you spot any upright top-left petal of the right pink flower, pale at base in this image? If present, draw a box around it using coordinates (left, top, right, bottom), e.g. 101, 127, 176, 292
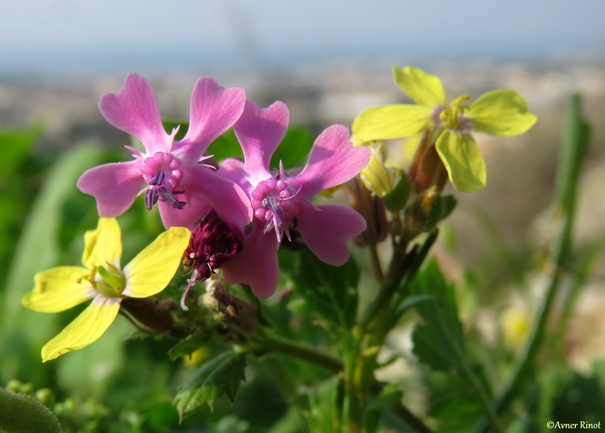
233, 101, 290, 184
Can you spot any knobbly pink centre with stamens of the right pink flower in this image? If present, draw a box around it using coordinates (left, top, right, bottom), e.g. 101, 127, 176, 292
251, 177, 298, 242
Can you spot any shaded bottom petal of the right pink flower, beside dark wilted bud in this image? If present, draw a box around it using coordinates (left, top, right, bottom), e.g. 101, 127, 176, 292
222, 224, 279, 299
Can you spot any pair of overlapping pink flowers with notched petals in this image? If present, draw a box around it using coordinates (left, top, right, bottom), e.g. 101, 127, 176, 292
78, 74, 370, 298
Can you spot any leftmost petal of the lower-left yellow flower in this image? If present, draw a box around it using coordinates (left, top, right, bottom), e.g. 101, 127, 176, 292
21, 266, 92, 313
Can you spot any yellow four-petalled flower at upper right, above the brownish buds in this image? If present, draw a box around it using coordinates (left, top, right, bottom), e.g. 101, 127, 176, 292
353, 66, 536, 192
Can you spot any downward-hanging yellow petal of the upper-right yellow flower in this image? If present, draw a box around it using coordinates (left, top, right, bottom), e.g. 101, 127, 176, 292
436, 130, 486, 192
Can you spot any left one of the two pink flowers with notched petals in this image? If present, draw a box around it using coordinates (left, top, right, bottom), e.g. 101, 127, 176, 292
78, 74, 252, 228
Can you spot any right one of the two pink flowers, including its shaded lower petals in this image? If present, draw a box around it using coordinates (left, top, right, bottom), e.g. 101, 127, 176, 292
219, 101, 370, 298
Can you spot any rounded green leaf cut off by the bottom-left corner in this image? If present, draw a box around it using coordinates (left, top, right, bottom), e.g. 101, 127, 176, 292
0, 388, 63, 433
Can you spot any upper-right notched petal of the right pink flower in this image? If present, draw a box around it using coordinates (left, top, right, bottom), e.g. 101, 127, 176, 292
289, 125, 370, 200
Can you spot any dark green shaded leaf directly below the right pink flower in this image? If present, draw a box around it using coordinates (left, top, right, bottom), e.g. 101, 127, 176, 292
294, 250, 360, 329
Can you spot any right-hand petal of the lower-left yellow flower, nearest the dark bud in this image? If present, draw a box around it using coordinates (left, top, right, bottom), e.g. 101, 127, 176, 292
122, 227, 191, 298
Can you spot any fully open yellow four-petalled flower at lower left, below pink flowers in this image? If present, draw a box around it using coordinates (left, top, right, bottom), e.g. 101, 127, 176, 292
22, 218, 190, 362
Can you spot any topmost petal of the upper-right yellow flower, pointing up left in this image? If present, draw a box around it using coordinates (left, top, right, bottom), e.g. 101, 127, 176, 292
393, 66, 447, 108
